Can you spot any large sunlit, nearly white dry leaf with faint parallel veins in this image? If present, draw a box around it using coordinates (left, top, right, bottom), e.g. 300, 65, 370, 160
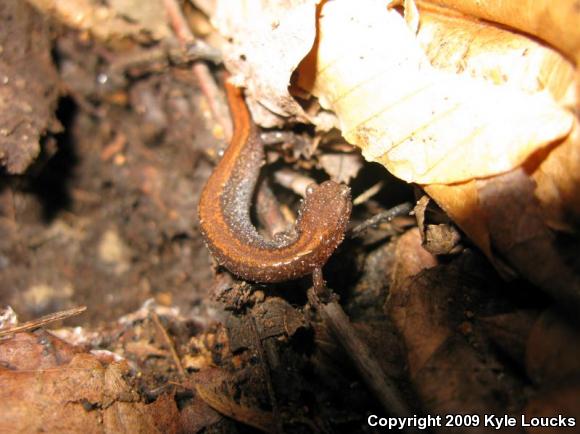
304, 0, 573, 184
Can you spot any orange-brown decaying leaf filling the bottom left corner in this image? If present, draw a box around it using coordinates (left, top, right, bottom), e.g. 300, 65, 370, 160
0, 332, 179, 433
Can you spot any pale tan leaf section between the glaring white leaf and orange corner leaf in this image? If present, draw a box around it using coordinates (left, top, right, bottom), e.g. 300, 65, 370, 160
417, 3, 575, 106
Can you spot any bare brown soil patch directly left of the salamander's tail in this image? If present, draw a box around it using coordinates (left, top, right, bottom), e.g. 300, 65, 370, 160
0, 28, 218, 324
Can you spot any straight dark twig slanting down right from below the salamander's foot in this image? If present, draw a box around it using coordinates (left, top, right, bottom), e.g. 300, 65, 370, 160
308, 269, 412, 428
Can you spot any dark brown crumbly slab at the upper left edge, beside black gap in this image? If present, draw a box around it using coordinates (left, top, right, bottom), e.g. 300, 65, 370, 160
0, 1, 60, 174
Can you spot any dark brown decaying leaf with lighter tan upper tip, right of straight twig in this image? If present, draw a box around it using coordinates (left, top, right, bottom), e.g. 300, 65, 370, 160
385, 234, 523, 424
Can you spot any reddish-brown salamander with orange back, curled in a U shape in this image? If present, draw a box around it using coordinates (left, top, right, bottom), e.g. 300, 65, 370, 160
199, 83, 352, 282
